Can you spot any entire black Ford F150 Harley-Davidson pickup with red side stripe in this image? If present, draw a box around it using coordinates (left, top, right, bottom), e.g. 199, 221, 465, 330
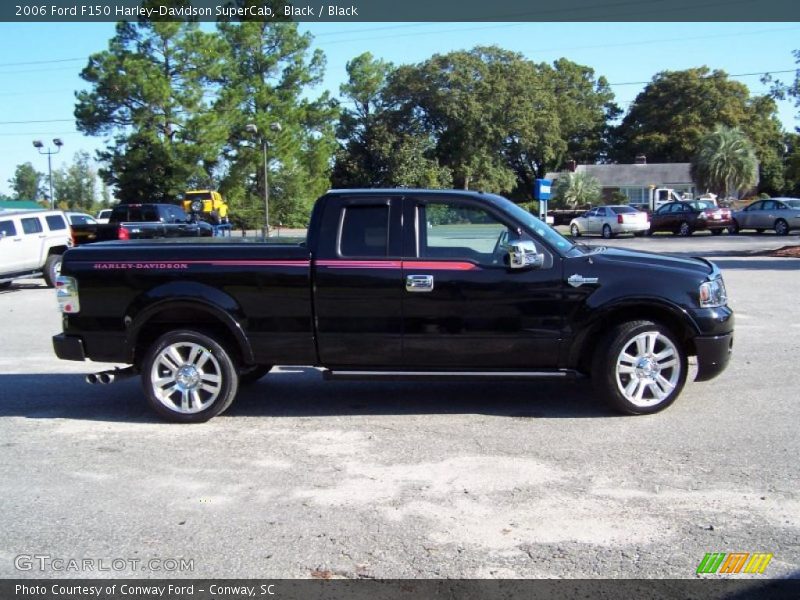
53, 189, 734, 422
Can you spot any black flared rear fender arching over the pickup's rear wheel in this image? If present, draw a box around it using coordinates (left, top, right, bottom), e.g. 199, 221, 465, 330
124, 281, 253, 363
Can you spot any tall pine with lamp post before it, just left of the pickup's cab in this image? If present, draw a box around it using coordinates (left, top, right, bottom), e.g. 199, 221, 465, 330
213, 22, 338, 226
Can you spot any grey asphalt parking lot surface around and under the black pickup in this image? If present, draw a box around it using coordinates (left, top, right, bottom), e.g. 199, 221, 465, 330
0, 235, 800, 578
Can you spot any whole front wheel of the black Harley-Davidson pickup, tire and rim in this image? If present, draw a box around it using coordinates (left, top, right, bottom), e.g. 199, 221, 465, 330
592, 321, 688, 415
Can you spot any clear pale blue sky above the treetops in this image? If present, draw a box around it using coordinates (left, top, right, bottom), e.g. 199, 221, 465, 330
0, 23, 800, 194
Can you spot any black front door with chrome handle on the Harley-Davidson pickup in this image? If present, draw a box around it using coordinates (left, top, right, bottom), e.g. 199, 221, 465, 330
403, 197, 563, 370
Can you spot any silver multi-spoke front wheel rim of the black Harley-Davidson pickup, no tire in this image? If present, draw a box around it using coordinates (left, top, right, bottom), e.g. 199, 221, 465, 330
615, 331, 681, 408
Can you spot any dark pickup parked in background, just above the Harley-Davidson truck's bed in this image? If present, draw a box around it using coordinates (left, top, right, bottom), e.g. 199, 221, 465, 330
72, 204, 214, 246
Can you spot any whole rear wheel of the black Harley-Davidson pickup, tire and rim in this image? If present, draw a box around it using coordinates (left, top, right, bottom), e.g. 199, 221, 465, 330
141, 329, 239, 423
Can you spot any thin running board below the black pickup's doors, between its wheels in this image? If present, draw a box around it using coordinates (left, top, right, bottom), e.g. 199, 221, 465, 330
322, 369, 583, 381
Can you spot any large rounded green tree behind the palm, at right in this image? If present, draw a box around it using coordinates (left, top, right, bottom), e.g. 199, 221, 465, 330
611, 67, 783, 191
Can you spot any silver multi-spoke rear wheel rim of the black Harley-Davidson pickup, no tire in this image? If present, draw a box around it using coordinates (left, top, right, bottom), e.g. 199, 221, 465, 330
150, 342, 223, 415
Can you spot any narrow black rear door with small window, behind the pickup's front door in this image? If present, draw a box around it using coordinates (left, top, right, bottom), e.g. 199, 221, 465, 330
312, 194, 403, 368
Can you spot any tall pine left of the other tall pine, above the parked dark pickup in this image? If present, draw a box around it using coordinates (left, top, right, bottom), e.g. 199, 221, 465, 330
75, 18, 225, 202
